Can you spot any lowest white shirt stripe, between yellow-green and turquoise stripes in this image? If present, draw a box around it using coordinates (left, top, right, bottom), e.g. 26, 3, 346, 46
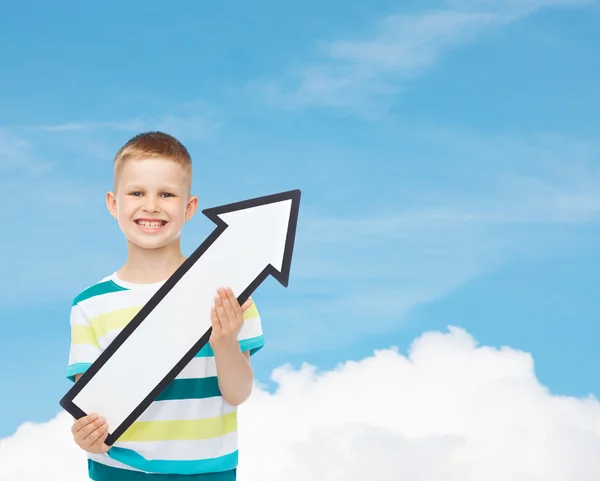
115, 431, 238, 461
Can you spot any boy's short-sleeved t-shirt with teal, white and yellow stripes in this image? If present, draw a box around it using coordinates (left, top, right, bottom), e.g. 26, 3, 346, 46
67, 273, 264, 481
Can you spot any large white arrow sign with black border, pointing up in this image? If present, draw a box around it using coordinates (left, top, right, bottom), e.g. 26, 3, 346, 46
60, 190, 300, 445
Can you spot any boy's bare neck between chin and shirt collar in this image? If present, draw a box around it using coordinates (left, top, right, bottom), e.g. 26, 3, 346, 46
117, 240, 185, 284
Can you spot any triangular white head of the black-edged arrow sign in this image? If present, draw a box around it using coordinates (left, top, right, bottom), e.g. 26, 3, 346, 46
202, 190, 301, 287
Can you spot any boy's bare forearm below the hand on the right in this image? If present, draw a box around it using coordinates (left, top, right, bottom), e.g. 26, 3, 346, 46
213, 341, 254, 406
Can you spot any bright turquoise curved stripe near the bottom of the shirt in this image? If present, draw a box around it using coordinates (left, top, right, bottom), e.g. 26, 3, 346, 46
108, 446, 238, 479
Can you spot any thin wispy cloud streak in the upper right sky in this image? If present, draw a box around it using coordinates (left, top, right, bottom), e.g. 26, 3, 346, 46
251, 0, 592, 112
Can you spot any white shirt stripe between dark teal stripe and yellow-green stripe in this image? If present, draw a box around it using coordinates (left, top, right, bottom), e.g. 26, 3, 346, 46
137, 396, 236, 421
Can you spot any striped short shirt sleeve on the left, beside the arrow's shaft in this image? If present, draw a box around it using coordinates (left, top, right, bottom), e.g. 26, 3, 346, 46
67, 304, 101, 382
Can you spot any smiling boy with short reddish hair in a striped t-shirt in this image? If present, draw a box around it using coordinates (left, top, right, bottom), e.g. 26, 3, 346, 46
67, 132, 264, 481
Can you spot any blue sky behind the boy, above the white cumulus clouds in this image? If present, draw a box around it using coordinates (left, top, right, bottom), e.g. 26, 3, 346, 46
0, 0, 600, 437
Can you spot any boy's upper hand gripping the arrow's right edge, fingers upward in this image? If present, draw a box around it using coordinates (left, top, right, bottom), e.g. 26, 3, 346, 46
209, 287, 253, 349
